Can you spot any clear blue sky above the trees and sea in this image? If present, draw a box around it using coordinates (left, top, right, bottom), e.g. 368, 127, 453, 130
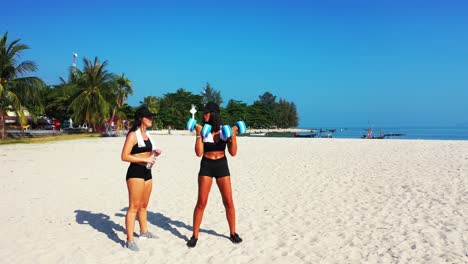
0, 0, 468, 127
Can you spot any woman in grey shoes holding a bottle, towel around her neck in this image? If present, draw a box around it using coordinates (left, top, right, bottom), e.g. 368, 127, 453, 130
121, 106, 161, 251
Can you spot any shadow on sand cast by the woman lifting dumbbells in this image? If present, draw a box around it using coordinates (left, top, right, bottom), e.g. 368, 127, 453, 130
115, 207, 229, 241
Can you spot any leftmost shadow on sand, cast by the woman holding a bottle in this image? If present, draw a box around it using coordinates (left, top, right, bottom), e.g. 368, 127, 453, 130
75, 210, 125, 247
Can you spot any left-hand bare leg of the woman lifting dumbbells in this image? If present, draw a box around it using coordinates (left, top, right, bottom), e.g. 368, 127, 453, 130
193, 176, 213, 238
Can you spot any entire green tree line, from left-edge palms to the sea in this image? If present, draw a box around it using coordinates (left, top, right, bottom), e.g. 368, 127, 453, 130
0, 33, 298, 138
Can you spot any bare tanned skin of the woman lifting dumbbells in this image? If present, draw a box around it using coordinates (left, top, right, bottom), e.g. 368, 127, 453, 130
193, 113, 238, 239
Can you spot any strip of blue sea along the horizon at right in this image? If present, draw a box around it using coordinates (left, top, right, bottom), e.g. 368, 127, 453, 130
302, 126, 468, 140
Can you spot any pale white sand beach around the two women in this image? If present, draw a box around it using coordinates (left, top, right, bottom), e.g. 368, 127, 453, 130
0, 135, 468, 264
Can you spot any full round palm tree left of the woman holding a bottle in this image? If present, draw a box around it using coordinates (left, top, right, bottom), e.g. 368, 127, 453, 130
70, 57, 115, 129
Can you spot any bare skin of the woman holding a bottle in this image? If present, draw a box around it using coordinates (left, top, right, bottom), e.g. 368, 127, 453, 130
121, 117, 161, 241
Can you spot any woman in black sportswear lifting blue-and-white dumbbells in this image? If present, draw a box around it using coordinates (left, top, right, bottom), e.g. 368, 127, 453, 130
187, 102, 242, 247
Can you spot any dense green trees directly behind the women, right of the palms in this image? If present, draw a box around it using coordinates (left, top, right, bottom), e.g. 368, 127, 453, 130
140, 88, 299, 129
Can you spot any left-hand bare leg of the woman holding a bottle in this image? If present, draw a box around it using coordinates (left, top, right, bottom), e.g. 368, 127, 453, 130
125, 178, 145, 241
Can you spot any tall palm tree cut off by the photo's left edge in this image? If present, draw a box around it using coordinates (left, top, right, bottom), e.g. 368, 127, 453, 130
0, 32, 44, 139
